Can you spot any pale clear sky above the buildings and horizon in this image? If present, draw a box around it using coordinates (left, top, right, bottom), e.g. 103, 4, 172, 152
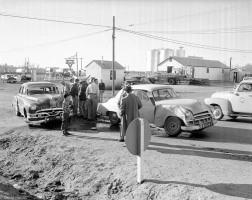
0, 0, 252, 71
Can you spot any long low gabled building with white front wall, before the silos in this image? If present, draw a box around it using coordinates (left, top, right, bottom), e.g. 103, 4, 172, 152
158, 56, 230, 81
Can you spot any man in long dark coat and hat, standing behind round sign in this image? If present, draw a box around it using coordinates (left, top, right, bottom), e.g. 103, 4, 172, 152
119, 85, 142, 142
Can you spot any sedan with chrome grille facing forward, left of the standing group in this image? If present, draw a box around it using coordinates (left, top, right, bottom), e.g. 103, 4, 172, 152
12, 82, 63, 126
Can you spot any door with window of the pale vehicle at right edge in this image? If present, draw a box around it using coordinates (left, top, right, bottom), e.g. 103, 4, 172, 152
230, 83, 252, 113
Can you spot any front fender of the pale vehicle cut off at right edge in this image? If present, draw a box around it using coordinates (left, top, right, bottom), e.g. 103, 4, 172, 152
205, 98, 232, 115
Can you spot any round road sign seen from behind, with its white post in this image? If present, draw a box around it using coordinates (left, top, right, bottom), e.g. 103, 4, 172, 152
126, 118, 151, 184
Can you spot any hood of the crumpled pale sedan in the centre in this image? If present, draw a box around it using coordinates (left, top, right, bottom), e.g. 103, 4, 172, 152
156, 99, 205, 114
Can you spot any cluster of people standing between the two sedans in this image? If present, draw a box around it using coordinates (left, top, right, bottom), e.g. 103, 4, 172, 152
61, 77, 105, 135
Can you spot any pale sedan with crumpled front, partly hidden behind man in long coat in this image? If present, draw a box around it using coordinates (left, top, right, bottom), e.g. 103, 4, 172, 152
97, 84, 216, 137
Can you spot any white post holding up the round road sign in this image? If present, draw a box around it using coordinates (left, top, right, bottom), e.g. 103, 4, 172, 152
137, 118, 144, 184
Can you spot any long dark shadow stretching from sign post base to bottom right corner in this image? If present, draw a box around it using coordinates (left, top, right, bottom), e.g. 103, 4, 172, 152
144, 179, 252, 199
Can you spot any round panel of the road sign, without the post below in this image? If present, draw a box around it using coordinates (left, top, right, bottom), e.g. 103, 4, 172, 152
126, 118, 151, 155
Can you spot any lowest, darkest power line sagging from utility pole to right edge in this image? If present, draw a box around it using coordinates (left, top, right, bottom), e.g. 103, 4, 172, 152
116, 28, 252, 53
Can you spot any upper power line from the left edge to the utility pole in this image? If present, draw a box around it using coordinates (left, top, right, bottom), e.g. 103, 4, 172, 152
0, 13, 112, 28
